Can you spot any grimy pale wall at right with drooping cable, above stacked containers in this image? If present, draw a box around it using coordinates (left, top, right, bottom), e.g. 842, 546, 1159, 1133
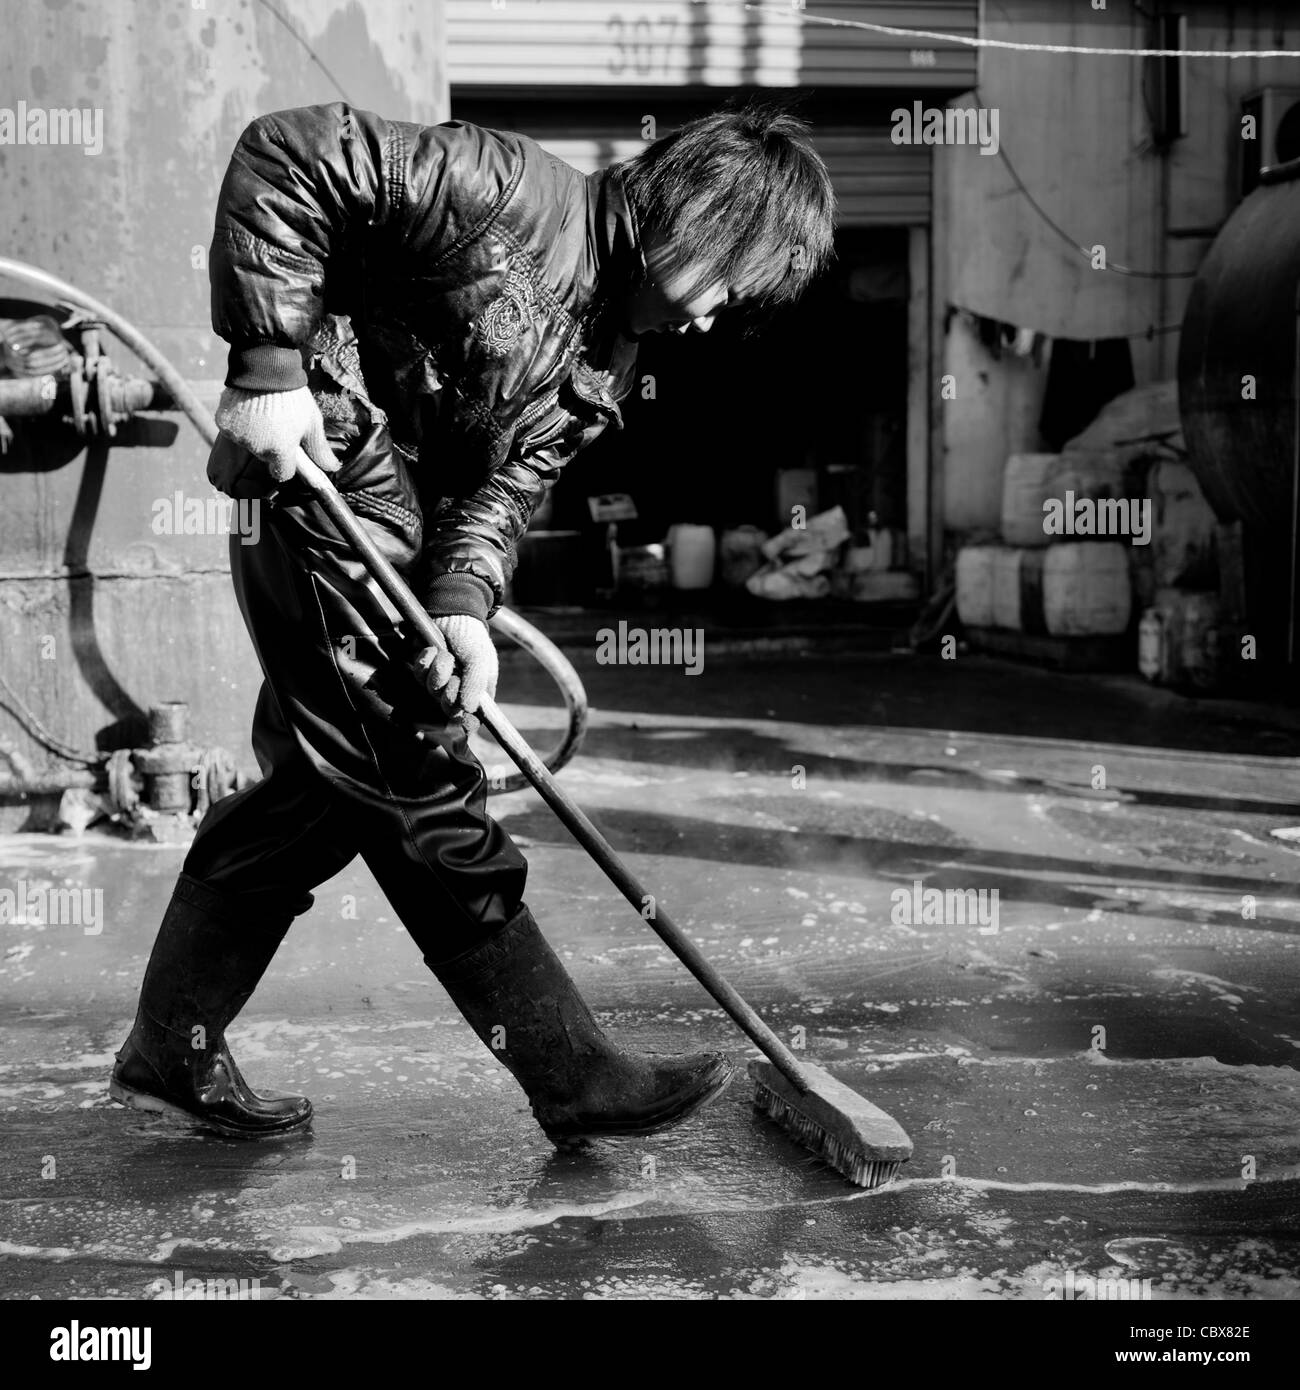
934, 0, 1300, 534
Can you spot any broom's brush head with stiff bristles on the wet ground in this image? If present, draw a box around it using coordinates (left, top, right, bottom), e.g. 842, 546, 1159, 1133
749, 1061, 912, 1188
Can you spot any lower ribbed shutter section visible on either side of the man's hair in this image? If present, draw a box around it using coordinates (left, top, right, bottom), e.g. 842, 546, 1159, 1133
522, 122, 930, 227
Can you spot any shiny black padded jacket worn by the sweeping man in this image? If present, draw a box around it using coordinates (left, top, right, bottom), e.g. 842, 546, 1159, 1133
209, 103, 645, 619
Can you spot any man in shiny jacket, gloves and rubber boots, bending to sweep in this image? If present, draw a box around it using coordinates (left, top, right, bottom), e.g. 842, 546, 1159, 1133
110, 103, 834, 1141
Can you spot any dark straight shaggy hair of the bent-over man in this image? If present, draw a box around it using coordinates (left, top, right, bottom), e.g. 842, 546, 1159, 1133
619, 100, 836, 320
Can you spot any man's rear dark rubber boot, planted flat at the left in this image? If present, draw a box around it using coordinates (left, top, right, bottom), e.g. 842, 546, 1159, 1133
108, 874, 311, 1138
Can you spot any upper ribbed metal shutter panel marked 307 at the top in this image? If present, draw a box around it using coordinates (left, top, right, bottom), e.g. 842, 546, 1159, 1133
446, 0, 979, 92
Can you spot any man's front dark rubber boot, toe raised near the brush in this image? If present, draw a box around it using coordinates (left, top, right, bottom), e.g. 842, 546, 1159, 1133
425, 908, 733, 1140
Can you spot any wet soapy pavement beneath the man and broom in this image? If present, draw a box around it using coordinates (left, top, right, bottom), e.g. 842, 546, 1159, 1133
0, 656, 1300, 1300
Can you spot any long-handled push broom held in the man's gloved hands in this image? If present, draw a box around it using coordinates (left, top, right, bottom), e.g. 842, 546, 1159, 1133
298, 449, 912, 1187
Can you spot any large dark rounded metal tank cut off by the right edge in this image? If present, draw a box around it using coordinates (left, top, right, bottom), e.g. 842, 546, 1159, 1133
1178, 160, 1300, 666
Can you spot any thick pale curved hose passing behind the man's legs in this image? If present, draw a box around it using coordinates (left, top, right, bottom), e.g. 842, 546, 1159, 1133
0, 256, 587, 792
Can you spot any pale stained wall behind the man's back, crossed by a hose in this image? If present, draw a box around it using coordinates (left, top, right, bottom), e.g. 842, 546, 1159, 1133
0, 0, 449, 776
